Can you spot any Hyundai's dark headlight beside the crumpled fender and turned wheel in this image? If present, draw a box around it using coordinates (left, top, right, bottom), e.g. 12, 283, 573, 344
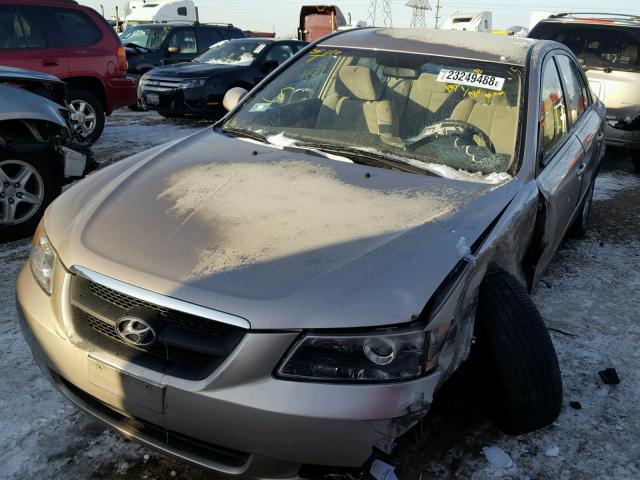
277, 327, 428, 383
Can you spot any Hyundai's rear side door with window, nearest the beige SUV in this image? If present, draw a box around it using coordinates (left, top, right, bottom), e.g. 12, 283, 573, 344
556, 55, 604, 200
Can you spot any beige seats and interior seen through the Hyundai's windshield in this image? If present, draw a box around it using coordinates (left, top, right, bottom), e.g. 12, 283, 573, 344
316, 65, 518, 161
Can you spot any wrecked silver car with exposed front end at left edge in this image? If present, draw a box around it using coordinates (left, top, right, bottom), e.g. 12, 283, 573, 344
0, 66, 93, 241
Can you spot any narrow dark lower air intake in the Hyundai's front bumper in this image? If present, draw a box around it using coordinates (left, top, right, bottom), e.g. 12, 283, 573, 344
57, 372, 249, 468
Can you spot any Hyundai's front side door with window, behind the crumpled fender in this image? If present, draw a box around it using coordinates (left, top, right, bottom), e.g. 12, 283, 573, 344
534, 55, 585, 284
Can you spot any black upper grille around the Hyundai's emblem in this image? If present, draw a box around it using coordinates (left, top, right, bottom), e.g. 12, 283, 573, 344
71, 275, 244, 379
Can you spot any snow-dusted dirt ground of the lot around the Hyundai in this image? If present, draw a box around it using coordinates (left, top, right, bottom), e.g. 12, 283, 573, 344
0, 111, 640, 480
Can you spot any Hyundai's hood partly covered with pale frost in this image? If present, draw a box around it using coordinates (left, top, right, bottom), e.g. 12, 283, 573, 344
45, 129, 518, 329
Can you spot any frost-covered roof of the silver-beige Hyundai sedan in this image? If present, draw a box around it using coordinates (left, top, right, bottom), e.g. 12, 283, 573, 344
319, 28, 540, 65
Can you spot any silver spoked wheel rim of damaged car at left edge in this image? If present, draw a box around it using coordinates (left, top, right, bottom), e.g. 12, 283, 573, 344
0, 160, 44, 225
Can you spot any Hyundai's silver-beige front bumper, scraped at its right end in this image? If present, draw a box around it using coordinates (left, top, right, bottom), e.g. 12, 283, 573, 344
16, 264, 440, 479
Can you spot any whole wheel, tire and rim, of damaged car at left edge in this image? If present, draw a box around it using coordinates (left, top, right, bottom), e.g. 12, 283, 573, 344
0, 151, 62, 242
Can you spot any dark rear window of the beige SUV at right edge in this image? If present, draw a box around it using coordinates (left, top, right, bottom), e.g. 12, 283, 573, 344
530, 22, 640, 71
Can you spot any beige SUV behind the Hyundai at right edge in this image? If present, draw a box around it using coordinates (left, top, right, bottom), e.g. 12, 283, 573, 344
529, 13, 640, 173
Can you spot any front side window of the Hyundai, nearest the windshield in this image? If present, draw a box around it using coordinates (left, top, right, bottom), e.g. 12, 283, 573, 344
539, 61, 568, 161
